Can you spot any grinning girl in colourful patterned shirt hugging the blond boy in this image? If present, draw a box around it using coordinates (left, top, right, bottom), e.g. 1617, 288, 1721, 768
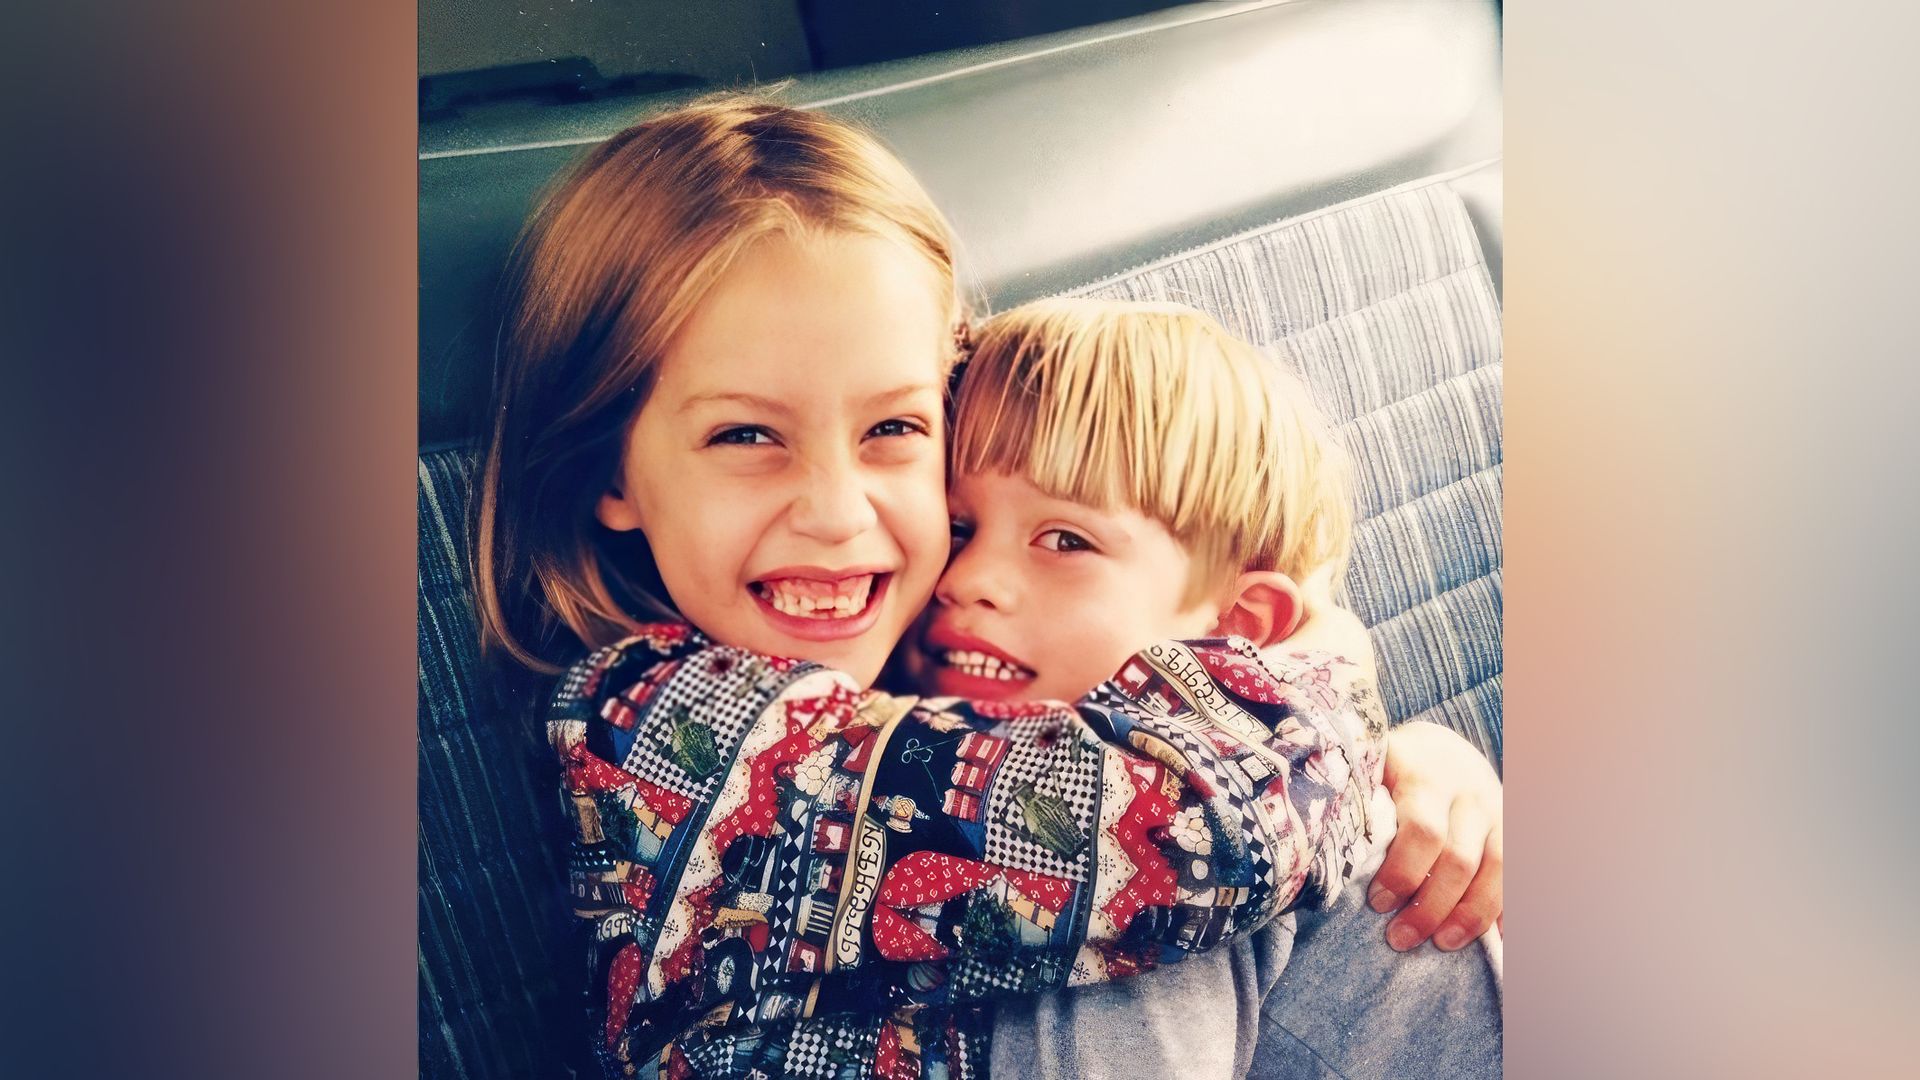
476, 98, 1489, 1074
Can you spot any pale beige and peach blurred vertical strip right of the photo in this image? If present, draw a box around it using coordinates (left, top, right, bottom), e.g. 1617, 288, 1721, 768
1505, 0, 1920, 1076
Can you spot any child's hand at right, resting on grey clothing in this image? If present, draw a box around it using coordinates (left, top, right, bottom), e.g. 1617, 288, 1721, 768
1367, 721, 1503, 951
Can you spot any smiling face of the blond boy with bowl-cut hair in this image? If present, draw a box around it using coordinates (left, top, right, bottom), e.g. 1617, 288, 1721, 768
920, 466, 1219, 701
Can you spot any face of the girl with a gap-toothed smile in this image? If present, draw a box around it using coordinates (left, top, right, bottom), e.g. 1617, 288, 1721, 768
597, 234, 952, 686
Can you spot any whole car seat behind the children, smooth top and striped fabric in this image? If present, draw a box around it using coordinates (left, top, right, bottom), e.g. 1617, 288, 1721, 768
419, 0, 1501, 1078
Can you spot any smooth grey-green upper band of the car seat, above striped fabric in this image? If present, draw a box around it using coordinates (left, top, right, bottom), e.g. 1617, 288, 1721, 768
420, 0, 1501, 444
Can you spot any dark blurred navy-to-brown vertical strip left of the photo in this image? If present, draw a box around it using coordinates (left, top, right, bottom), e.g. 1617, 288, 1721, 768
0, 0, 417, 1078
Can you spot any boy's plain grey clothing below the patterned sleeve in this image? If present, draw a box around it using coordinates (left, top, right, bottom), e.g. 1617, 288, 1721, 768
993, 837, 1501, 1080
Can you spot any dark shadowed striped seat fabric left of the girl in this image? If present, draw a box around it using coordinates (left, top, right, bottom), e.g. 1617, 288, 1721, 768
419, 452, 586, 1080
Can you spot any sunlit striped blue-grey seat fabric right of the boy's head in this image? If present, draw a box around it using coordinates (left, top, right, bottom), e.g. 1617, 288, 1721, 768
1079, 181, 1501, 769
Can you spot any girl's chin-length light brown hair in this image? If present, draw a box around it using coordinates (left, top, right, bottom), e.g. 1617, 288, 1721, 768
472, 94, 966, 673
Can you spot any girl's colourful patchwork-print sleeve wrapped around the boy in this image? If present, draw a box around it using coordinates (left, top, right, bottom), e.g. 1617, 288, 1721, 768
549, 626, 1382, 1070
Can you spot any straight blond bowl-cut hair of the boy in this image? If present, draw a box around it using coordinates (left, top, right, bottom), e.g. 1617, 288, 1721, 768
952, 298, 1354, 601
